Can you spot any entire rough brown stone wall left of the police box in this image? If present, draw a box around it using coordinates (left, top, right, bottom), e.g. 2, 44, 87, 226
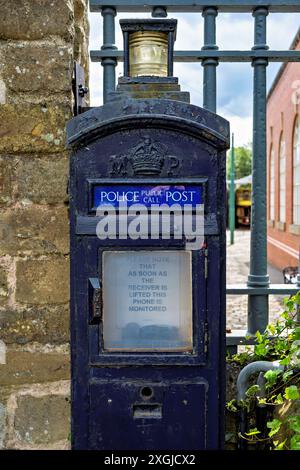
0, 0, 88, 449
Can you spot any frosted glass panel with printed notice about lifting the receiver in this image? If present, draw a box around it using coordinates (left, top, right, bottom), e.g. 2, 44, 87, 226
103, 251, 193, 351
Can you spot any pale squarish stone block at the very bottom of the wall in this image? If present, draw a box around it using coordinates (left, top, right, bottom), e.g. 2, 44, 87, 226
15, 395, 70, 445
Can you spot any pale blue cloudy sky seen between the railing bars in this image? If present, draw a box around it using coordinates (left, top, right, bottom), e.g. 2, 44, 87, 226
89, 13, 300, 146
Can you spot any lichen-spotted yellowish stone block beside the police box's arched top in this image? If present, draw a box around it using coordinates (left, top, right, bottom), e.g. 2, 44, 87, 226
0, 103, 72, 154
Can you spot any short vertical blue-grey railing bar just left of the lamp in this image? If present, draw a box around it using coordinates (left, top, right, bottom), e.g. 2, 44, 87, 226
101, 6, 117, 103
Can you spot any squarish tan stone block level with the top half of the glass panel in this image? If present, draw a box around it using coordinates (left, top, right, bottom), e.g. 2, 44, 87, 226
16, 256, 69, 305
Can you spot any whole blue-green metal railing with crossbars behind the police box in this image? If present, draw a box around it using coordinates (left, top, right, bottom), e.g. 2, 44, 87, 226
90, 0, 300, 347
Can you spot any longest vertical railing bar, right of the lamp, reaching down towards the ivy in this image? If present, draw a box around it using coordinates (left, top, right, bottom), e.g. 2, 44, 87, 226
248, 7, 269, 335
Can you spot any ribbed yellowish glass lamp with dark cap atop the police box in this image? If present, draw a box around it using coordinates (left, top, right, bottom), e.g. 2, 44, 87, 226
120, 19, 177, 78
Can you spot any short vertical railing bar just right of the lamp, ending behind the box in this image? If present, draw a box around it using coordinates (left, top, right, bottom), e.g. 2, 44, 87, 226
202, 7, 218, 113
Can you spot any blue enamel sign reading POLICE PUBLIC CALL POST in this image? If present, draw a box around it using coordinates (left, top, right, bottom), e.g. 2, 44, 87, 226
93, 184, 203, 208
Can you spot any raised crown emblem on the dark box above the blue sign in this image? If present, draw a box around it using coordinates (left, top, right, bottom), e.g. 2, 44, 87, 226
129, 137, 167, 175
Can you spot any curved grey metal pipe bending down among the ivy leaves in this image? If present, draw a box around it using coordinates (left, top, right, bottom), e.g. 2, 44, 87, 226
237, 361, 284, 450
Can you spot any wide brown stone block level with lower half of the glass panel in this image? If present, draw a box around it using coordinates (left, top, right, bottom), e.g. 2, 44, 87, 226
0, 304, 70, 344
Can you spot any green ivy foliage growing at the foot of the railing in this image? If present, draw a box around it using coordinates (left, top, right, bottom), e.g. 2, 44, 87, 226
227, 291, 300, 450
